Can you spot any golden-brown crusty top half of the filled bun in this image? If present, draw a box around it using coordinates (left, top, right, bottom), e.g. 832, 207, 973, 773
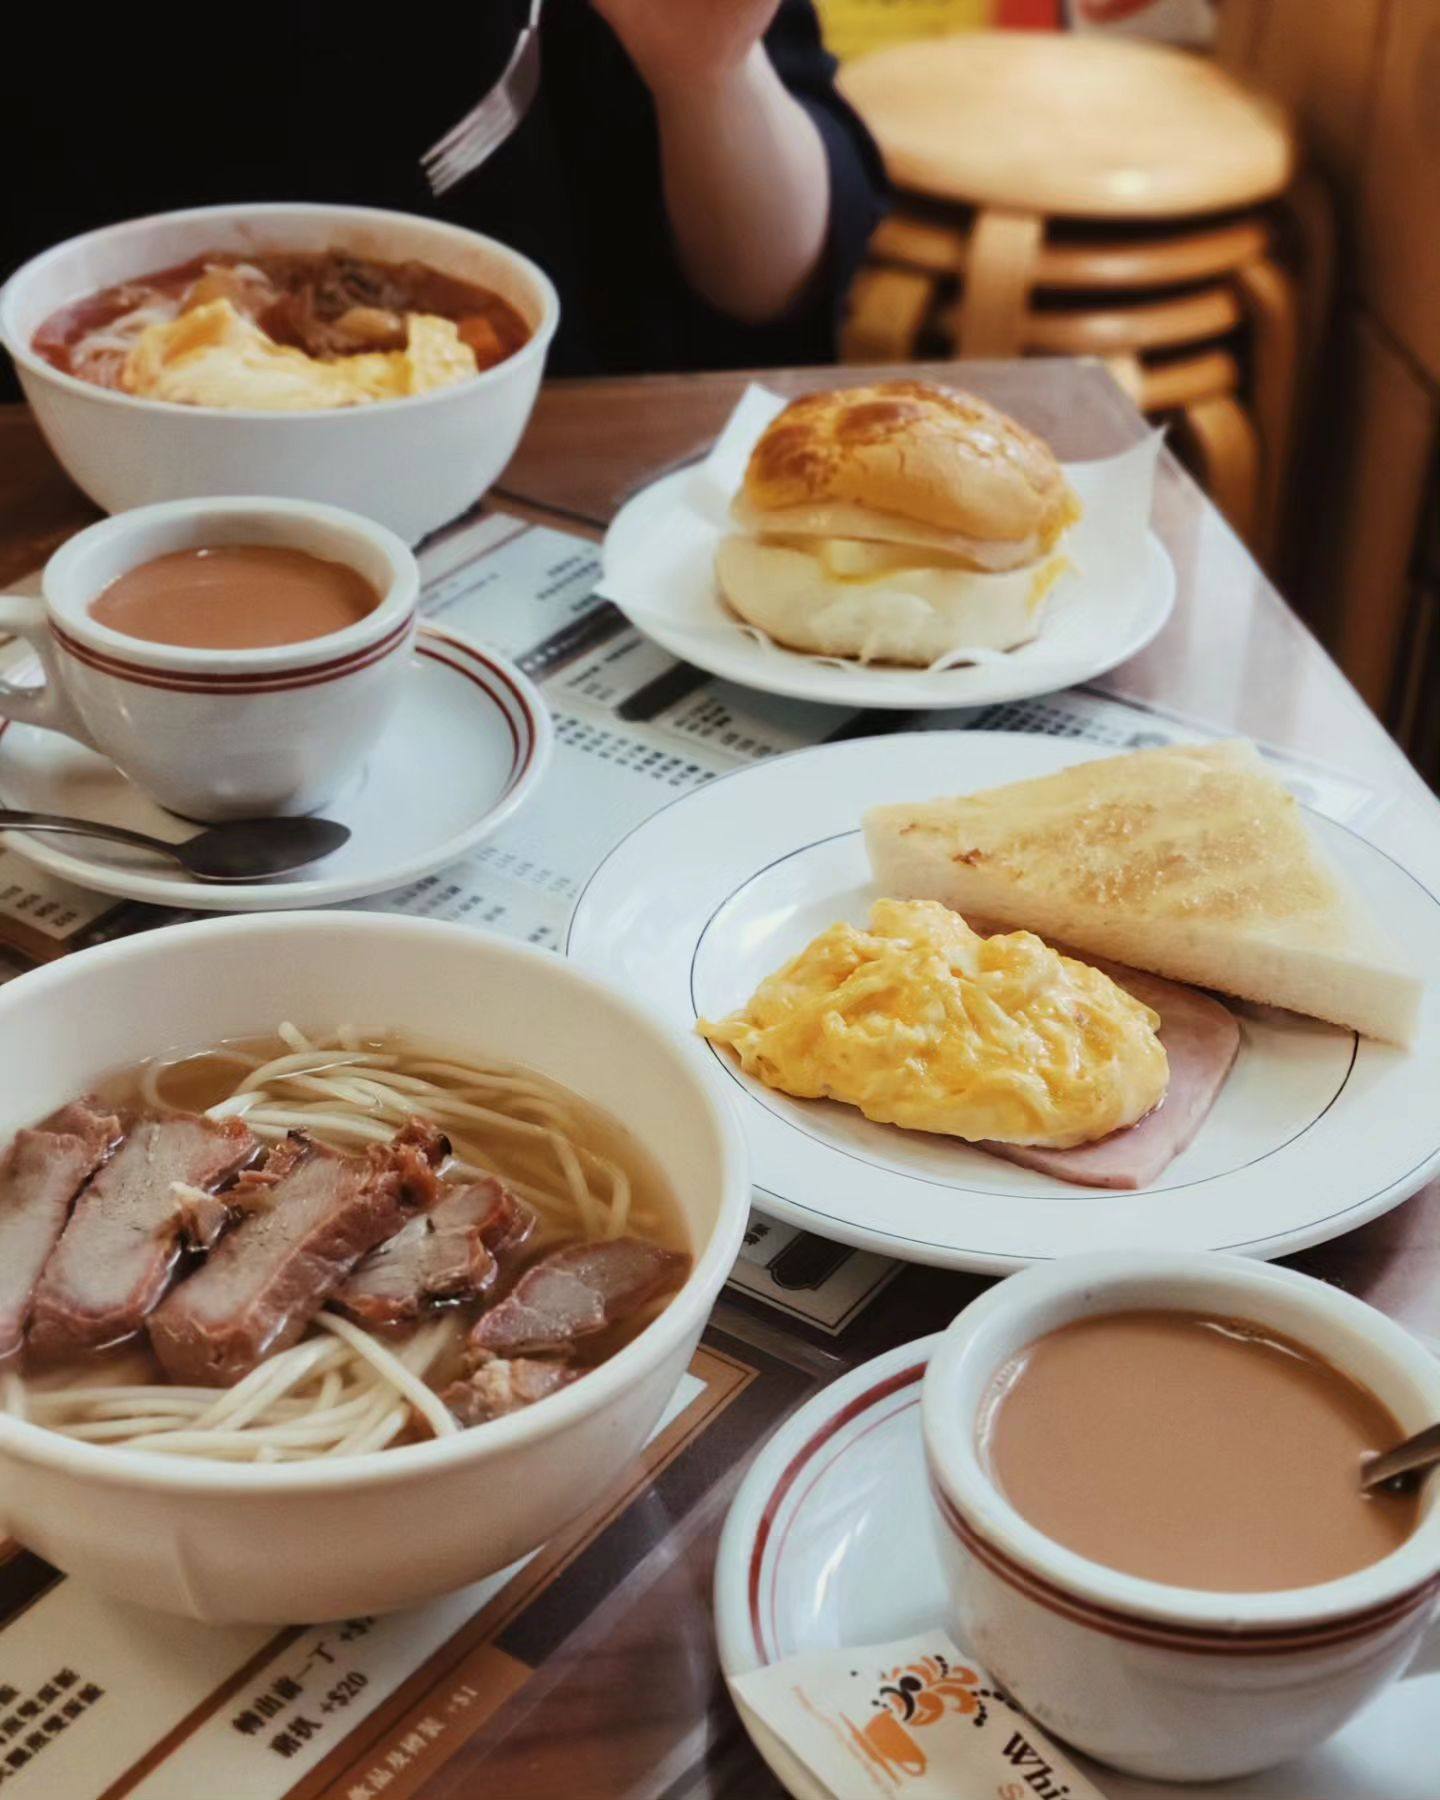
734, 382, 1076, 569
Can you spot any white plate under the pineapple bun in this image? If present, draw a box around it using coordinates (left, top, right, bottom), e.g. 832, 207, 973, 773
601, 468, 1175, 709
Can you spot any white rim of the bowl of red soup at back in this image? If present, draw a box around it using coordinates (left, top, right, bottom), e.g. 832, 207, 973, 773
0, 200, 560, 423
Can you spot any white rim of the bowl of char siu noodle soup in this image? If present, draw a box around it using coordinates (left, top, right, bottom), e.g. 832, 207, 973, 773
0, 909, 751, 1496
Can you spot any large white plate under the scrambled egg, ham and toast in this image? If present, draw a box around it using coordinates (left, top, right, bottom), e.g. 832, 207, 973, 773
569, 731, 1440, 1273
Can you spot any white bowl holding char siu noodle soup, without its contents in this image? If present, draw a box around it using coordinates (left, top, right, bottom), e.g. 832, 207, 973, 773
0, 913, 751, 1624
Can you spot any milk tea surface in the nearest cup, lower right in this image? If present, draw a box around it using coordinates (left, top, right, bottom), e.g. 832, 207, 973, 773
979, 1310, 1418, 1593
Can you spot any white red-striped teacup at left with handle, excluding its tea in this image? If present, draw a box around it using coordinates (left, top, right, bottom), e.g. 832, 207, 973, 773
0, 499, 419, 819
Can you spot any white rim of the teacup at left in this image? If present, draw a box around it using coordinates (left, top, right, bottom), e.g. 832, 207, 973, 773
41, 493, 419, 673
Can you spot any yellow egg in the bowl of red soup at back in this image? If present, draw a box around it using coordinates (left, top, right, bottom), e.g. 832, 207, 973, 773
122, 299, 475, 412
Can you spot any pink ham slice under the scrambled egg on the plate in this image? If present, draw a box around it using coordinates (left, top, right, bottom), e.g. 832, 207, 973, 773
976, 956, 1240, 1188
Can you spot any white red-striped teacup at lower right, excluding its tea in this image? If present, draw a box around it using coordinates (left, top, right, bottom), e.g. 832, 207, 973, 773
923, 1251, 1440, 1782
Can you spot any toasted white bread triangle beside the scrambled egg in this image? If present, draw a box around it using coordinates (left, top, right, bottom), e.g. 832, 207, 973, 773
864, 742, 1422, 1044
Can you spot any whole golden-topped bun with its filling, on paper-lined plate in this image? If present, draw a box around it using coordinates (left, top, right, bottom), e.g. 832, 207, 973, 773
716, 382, 1080, 666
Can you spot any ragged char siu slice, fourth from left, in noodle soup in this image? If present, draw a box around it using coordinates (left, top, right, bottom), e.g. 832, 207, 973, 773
335, 1175, 535, 1327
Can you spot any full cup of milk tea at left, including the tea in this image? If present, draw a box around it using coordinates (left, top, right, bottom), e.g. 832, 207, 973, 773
0, 497, 419, 821
